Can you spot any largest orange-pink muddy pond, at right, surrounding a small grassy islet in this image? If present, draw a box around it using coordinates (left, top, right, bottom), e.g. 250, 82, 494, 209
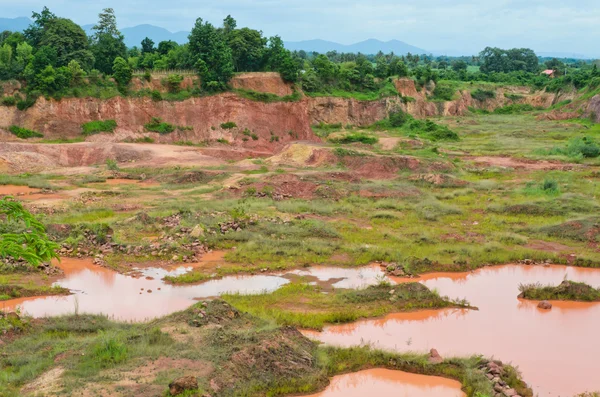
306, 265, 600, 396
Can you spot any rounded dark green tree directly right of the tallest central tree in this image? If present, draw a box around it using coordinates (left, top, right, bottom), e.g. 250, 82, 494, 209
228, 28, 267, 72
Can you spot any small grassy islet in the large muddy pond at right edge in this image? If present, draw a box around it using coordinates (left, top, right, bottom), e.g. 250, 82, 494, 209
519, 280, 600, 302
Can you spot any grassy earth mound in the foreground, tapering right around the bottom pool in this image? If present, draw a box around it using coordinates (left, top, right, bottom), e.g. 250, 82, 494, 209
0, 301, 531, 397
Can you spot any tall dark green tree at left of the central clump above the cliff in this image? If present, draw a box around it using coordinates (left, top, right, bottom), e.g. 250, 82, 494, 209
189, 18, 233, 91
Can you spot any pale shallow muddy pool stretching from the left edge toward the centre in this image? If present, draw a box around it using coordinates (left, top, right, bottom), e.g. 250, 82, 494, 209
0, 258, 390, 321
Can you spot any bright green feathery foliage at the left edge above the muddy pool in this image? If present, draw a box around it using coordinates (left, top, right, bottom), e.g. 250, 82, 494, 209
0, 197, 58, 266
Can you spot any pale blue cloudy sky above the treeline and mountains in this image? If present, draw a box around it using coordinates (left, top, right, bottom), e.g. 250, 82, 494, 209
0, 0, 600, 57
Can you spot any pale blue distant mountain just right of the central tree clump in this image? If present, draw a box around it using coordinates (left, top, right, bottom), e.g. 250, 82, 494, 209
285, 39, 429, 55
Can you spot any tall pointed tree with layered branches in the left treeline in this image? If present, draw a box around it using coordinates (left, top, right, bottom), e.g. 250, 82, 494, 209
91, 8, 127, 74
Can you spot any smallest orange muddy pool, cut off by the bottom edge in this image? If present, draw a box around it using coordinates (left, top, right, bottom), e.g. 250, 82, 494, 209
308, 369, 465, 397
